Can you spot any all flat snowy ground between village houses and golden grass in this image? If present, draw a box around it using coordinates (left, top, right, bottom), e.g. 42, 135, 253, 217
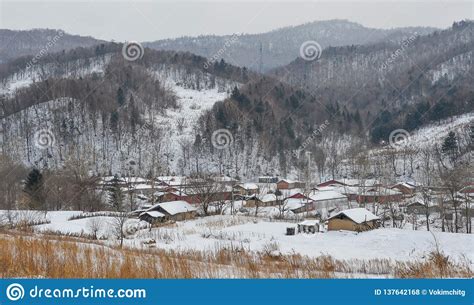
2, 211, 474, 266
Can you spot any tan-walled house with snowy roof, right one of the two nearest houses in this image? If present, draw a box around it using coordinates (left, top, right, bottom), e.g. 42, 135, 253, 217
328, 208, 380, 232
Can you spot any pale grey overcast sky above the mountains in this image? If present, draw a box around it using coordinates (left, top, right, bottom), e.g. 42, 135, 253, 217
0, 0, 474, 41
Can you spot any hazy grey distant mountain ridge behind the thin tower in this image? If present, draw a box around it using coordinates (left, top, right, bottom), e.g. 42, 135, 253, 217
144, 20, 436, 71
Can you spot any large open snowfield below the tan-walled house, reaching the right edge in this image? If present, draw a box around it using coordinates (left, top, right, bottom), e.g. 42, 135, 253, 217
130, 216, 474, 264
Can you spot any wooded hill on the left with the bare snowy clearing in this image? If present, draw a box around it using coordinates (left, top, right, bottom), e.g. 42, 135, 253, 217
0, 45, 286, 176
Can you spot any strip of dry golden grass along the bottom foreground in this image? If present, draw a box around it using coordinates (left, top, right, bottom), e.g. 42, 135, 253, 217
0, 232, 473, 278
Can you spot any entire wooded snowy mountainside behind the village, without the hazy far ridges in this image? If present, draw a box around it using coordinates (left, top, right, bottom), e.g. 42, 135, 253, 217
0, 22, 474, 181
